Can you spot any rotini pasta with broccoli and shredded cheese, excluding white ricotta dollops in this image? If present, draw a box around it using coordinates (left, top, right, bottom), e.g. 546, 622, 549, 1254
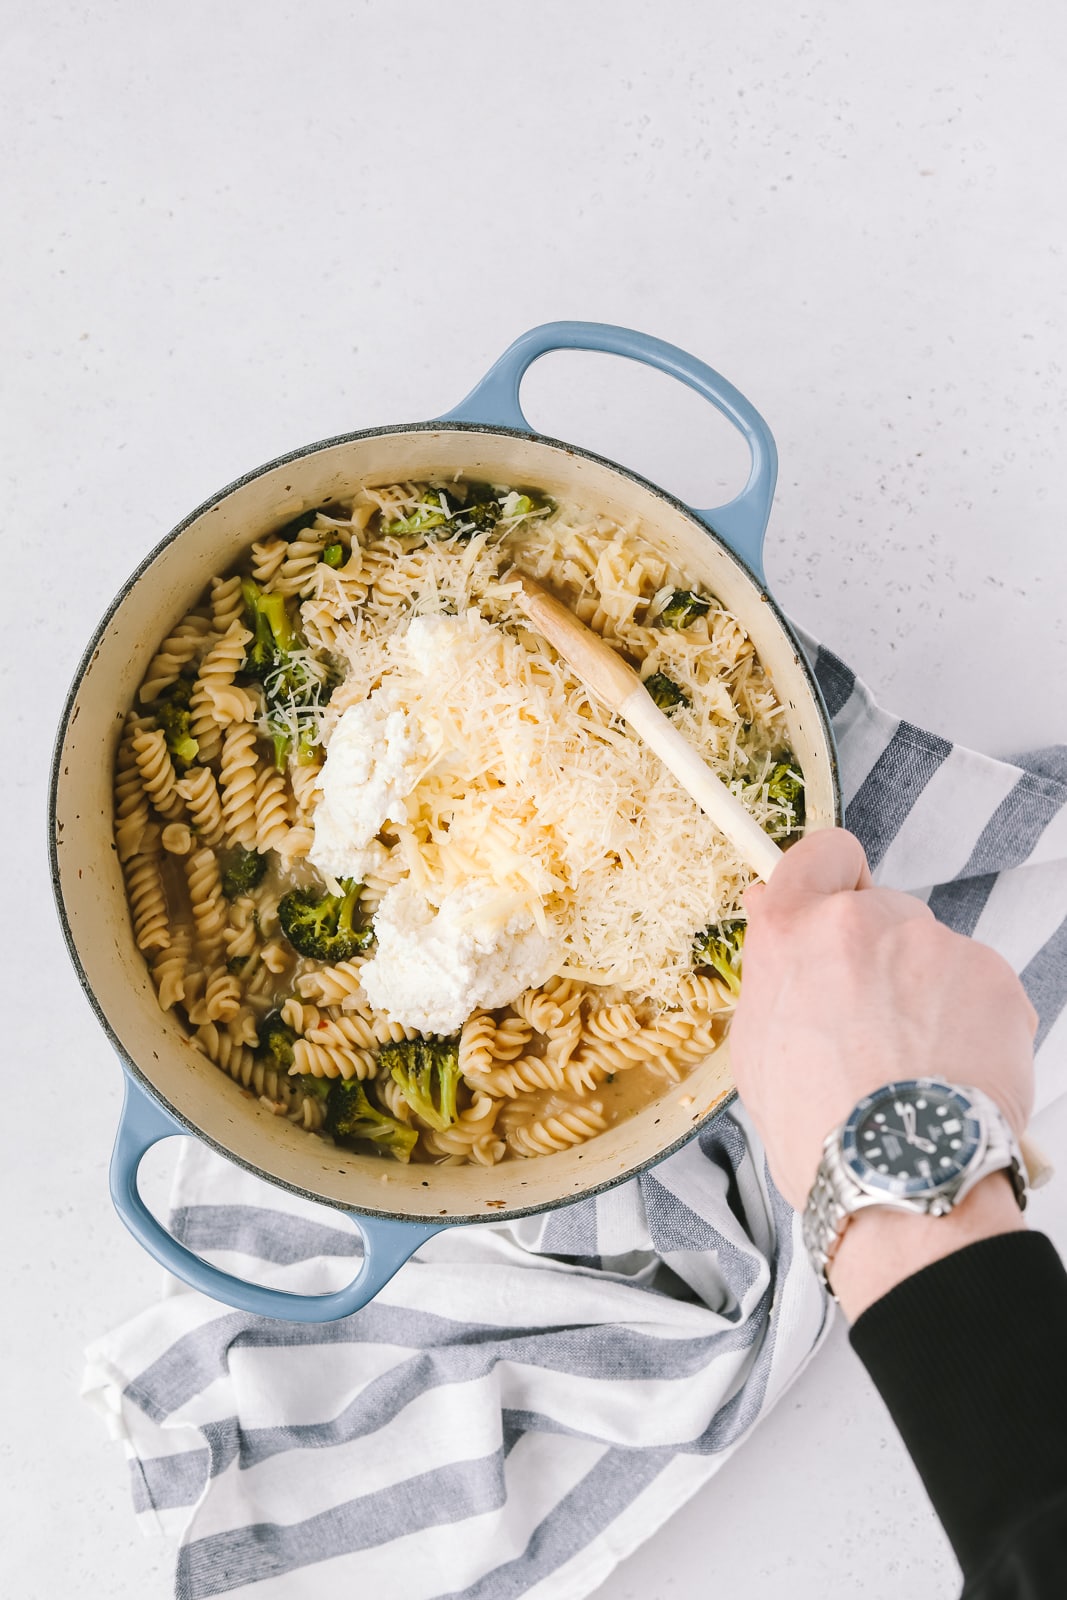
115, 482, 803, 1166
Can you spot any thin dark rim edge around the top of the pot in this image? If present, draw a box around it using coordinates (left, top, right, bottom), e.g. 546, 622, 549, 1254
48, 421, 845, 1227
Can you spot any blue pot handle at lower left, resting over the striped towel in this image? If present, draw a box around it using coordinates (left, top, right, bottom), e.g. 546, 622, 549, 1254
110, 1070, 448, 1322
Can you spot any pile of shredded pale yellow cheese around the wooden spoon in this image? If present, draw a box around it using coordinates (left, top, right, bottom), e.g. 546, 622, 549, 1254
306, 510, 784, 1003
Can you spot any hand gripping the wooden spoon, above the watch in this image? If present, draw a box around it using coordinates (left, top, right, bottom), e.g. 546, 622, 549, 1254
729, 829, 1037, 1210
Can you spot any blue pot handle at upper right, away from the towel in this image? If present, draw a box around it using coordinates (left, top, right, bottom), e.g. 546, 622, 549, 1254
437, 322, 777, 582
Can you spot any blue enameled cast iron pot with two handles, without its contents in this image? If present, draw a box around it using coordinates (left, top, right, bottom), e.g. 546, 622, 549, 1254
50, 322, 841, 1322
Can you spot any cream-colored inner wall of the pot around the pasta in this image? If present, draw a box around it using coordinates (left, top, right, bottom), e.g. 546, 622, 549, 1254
56, 429, 835, 1219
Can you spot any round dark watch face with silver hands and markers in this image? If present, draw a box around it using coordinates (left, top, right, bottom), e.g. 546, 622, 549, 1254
841, 1078, 982, 1195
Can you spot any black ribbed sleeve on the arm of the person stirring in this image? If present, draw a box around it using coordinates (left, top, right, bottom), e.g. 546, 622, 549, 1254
851, 1232, 1067, 1600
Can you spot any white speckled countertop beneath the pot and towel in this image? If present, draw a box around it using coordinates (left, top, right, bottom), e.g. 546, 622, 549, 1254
8, 0, 1067, 1600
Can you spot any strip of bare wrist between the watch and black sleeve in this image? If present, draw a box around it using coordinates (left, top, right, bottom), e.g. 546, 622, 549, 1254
827, 1171, 1025, 1322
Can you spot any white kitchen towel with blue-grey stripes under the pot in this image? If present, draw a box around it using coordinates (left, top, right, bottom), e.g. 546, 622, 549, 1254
86, 640, 1067, 1600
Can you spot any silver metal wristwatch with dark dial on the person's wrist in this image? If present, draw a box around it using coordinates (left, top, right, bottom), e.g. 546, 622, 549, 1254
803, 1078, 1027, 1293
